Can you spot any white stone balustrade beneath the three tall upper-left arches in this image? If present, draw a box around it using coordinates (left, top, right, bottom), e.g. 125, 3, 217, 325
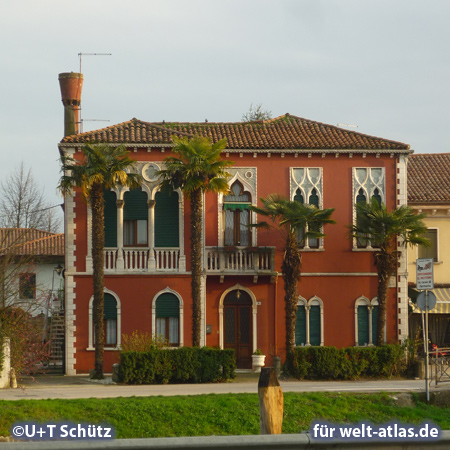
105, 247, 180, 272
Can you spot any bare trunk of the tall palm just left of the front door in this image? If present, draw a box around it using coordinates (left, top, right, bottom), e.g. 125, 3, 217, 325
190, 189, 202, 347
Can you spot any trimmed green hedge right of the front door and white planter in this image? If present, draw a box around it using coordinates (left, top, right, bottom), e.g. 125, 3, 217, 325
283, 345, 405, 380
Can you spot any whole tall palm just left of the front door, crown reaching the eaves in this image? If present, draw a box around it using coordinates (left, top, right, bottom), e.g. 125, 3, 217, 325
159, 136, 233, 347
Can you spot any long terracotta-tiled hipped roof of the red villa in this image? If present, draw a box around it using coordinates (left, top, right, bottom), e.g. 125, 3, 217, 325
61, 114, 409, 153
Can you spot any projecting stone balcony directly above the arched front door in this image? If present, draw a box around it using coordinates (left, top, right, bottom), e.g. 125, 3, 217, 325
204, 247, 276, 277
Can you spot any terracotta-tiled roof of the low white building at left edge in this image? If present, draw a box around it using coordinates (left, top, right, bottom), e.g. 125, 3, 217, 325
0, 228, 64, 256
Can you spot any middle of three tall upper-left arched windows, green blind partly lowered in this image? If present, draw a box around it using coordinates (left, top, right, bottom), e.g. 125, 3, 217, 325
123, 188, 148, 247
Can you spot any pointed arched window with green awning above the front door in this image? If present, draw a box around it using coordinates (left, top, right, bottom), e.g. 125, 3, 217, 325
223, 181, 251, 246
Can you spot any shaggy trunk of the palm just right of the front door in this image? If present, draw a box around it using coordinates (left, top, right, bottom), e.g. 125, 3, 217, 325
281, 232, 301, 353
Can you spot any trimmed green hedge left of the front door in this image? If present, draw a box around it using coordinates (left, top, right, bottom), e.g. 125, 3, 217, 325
119, 347, 236, 384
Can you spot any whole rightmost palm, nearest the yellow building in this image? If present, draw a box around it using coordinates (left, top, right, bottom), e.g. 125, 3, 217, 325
350, 197, 430, 345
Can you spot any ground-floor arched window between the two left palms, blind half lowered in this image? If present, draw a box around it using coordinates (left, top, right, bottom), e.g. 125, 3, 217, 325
155, 292, 180, 346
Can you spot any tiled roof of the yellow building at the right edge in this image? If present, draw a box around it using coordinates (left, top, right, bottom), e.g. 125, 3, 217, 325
408, 153, 450, 204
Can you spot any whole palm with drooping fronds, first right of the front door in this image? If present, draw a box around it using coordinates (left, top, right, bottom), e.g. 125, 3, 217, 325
250, 194, 335, 352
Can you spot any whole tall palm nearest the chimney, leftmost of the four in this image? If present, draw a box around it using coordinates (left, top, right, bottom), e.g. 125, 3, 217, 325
58, 144, 142, 379
